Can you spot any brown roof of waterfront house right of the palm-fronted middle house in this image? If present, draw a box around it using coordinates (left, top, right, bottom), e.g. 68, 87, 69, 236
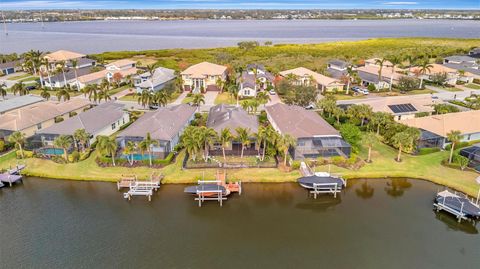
265, 103, 340, 138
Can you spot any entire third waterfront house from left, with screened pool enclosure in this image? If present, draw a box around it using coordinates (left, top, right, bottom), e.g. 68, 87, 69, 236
117, 104, 196, 158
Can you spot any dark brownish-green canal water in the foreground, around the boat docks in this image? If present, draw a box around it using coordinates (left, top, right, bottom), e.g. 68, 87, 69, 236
0, 178, 480, 269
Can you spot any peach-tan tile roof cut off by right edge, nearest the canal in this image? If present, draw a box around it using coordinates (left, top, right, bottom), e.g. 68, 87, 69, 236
400, 110, 480, 137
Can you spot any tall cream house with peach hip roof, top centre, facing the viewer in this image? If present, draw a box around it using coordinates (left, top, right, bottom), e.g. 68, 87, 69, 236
180, 62, 227, 93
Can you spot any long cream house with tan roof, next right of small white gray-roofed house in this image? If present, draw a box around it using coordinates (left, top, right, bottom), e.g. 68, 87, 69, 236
280, 67, 345, 92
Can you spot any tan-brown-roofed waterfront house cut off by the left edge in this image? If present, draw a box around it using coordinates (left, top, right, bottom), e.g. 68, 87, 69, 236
0, 98, 90, 138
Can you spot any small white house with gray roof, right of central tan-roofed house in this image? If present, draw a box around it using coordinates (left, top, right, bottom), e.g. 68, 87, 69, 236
237, 64, 275, 97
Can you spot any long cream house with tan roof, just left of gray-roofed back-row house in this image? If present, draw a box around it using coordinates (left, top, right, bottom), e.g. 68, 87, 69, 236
78, 59, 137, 89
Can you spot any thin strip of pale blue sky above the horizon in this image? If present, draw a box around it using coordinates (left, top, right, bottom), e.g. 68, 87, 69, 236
0, 0, 480, 10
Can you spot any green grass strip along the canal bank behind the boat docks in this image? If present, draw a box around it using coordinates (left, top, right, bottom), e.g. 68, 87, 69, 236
0, 139, 478, 195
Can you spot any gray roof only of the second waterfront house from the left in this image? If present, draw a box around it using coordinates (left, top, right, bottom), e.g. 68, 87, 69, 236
37, 101, 125, 135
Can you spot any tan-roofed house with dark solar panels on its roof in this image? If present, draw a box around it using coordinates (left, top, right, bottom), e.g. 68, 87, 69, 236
341, 95, 442, 120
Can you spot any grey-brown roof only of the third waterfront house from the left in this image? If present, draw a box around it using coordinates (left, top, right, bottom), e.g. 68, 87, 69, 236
118, 104, 196, 141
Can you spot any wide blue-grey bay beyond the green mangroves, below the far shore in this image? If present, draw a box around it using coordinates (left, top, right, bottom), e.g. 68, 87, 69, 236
0, 19, 480, 53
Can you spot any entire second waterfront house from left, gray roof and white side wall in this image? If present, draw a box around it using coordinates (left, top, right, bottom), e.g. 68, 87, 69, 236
36, 101, 130, 146
